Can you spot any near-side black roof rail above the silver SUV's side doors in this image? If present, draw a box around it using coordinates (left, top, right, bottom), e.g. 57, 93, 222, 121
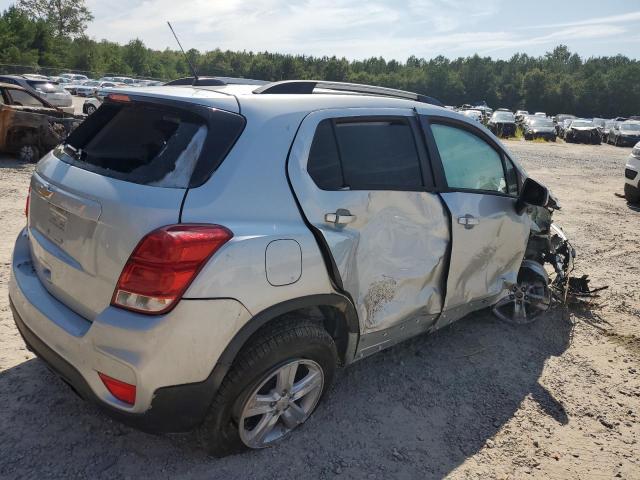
253, 80, 444, 107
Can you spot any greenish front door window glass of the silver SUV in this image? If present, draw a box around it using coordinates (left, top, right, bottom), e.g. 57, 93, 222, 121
431, 124, 509, 193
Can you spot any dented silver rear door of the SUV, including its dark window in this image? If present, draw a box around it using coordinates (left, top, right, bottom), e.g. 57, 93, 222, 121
288, 108, 449, 338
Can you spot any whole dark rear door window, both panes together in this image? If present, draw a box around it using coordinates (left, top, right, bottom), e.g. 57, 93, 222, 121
307, 117, 423, 191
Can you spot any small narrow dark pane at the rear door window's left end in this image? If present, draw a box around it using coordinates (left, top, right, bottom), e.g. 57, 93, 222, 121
307, 119, 344, 190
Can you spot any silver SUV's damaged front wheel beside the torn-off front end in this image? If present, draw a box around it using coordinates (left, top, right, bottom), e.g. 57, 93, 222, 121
493, 269, 551, 325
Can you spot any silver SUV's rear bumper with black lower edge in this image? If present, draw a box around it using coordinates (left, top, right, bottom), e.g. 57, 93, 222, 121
9, 231, 250, 432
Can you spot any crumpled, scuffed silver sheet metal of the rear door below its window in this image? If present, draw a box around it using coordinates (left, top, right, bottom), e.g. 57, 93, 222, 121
323, 191, 449, 332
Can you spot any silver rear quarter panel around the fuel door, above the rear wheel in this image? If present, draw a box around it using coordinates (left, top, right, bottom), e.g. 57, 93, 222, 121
182, 109, 333, 315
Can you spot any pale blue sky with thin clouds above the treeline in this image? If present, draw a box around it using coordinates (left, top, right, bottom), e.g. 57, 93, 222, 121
0, 0, 640, 61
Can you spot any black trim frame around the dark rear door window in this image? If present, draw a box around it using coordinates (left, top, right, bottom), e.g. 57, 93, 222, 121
306, 114, 436, 193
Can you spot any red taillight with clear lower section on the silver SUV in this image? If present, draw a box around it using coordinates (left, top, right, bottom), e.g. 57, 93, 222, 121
111, 224, 233, 314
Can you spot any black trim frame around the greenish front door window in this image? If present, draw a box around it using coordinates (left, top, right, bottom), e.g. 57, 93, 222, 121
420, 115, 521, 198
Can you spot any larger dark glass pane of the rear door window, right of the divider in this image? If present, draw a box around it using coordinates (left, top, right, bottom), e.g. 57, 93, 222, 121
336, 119, 422, 190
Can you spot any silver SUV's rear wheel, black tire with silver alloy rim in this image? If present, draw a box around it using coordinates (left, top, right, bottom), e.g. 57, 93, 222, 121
198, 318, 338, 457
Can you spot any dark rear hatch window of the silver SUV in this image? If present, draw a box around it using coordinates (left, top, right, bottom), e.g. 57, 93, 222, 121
55, 96, 244, 188
